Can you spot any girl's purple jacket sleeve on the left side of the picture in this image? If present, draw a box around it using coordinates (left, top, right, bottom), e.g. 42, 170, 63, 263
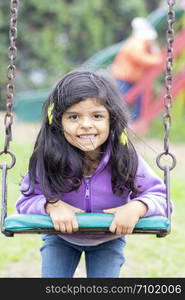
16, 173, 47, 215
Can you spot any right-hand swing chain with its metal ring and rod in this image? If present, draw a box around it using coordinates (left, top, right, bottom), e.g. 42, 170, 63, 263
156, 0, 176, 219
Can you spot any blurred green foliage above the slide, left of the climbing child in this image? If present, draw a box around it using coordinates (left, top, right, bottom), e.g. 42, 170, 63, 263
0, 0, 161, 109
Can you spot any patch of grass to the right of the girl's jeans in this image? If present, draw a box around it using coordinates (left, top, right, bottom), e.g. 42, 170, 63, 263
122, 179, 185, 277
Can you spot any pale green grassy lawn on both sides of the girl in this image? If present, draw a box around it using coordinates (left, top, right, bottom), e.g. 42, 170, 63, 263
0, 120, 185, 277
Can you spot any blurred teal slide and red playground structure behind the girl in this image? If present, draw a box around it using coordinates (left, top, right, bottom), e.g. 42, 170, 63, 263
14, 8, 185, 125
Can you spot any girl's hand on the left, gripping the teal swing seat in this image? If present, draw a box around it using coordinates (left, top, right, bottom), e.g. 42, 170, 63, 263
45, 200, 84, 233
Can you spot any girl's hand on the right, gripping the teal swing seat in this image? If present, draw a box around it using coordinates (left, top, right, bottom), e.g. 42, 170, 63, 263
103, 200, 147, 235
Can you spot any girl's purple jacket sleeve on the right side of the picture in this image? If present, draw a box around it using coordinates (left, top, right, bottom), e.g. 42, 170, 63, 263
131, 155, 173, 217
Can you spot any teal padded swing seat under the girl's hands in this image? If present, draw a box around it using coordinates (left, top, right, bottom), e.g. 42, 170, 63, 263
2, 213, 170, 237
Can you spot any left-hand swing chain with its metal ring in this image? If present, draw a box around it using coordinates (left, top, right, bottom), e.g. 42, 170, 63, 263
0, 0, 19, 169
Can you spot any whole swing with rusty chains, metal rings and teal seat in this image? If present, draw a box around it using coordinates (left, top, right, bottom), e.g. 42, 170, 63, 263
0, 0, 176, 237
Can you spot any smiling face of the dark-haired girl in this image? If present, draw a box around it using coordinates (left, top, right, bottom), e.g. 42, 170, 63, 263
62, 98, 109, 159
